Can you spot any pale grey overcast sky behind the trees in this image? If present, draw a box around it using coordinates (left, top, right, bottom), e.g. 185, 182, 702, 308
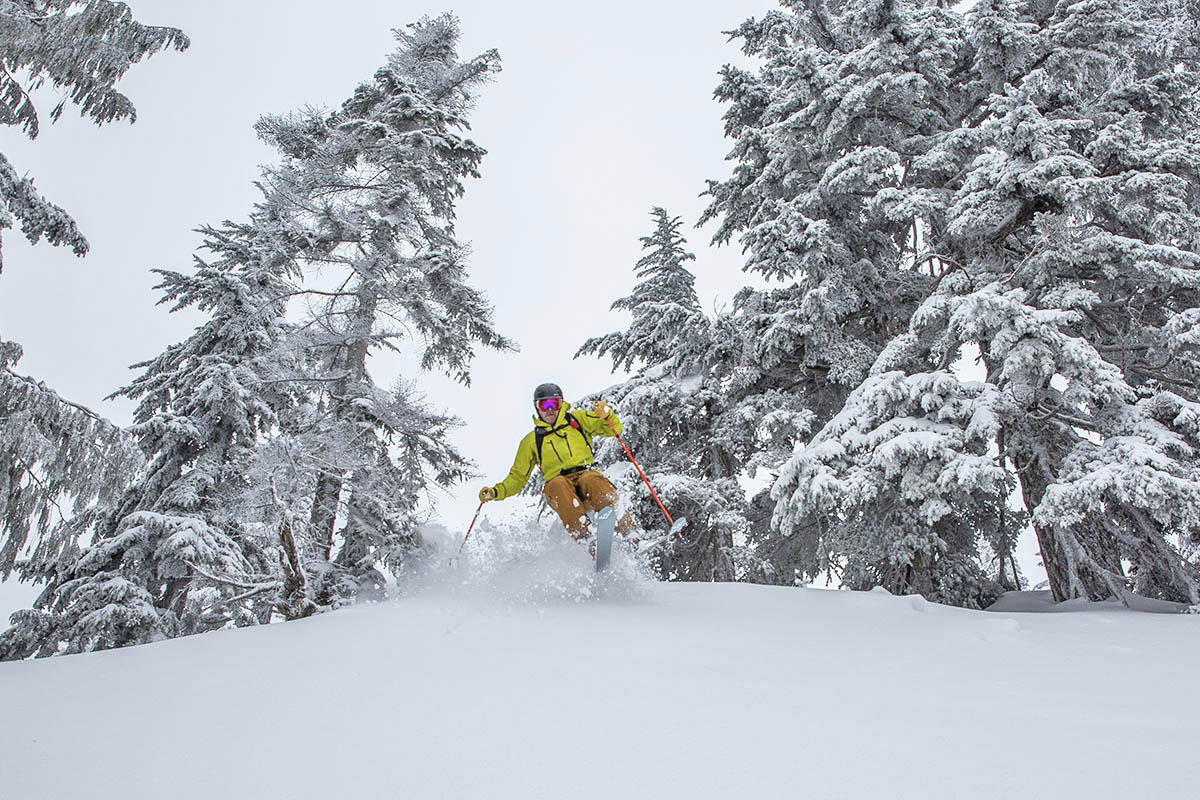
0, 0, 774, 575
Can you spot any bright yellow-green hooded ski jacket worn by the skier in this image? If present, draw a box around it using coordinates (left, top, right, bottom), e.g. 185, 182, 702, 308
493, 402, 622, 500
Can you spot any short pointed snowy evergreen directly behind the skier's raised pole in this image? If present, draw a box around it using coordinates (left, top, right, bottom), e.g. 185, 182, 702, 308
576, 207, 746, 581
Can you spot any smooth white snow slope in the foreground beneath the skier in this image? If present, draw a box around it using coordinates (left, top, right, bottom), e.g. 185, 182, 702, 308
0, 530, 1200, 800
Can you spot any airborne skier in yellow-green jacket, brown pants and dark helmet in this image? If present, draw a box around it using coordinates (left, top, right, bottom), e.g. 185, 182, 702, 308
479, 384, 634, 541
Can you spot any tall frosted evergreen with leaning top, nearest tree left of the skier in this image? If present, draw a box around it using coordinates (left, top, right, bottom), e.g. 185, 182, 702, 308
250, 14, 511, 602
